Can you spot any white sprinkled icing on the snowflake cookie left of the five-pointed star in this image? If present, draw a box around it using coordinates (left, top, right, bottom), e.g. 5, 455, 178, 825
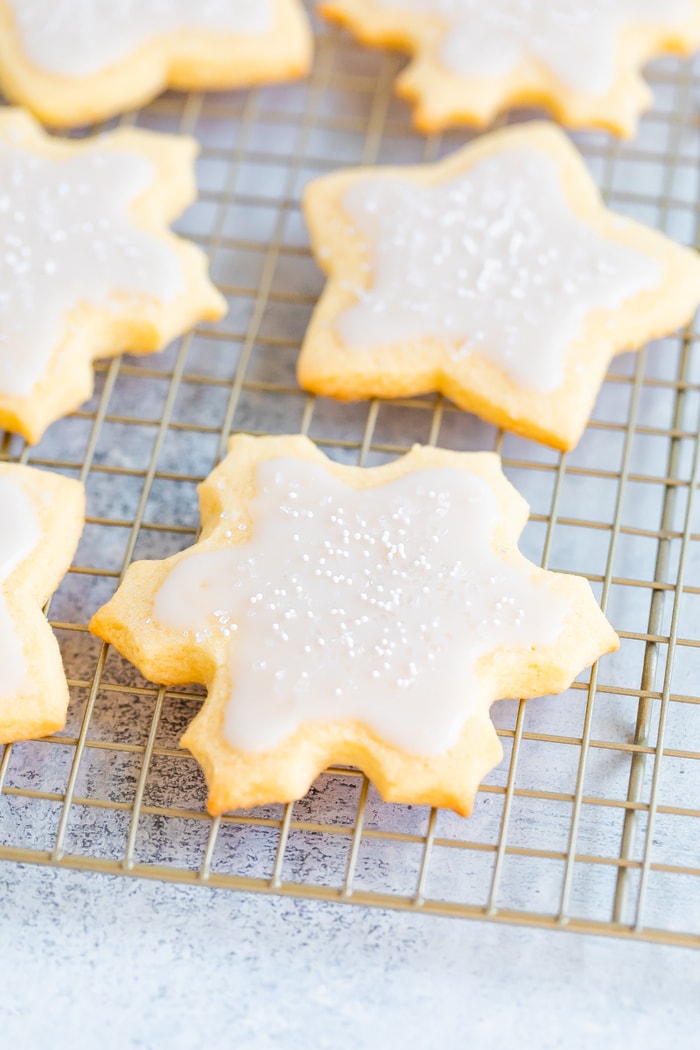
0, 139, 184, 396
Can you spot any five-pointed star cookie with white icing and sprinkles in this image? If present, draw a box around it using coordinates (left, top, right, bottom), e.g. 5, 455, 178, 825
298, 124, 700, 449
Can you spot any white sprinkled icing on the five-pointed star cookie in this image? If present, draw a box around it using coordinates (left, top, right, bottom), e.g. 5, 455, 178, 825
337, 148, 662, 393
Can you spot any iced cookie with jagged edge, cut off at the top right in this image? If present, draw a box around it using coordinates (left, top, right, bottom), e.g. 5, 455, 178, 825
320, 0, 700, 135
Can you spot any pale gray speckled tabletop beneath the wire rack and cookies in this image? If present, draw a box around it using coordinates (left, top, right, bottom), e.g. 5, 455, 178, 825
0, 0, 700, 1037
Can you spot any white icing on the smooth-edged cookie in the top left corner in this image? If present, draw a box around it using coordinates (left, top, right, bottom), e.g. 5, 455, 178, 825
8, 0, 273, 77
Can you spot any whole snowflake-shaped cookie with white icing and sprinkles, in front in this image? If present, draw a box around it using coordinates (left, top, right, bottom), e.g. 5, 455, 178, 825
90, 436, 618, 814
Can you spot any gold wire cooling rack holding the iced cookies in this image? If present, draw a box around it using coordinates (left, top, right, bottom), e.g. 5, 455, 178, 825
0, 2, 700, 946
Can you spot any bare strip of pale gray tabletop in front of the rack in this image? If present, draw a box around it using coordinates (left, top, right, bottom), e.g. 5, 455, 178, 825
0, 865, 700, 1050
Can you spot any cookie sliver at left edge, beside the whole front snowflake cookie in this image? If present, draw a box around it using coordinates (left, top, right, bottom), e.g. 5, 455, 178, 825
0, 463, 85, 743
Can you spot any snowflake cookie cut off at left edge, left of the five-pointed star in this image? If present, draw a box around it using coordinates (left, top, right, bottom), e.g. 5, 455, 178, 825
0, 109, 226, 442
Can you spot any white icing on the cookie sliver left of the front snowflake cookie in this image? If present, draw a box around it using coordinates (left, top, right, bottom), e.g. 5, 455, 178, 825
0, 475, 41, 697
